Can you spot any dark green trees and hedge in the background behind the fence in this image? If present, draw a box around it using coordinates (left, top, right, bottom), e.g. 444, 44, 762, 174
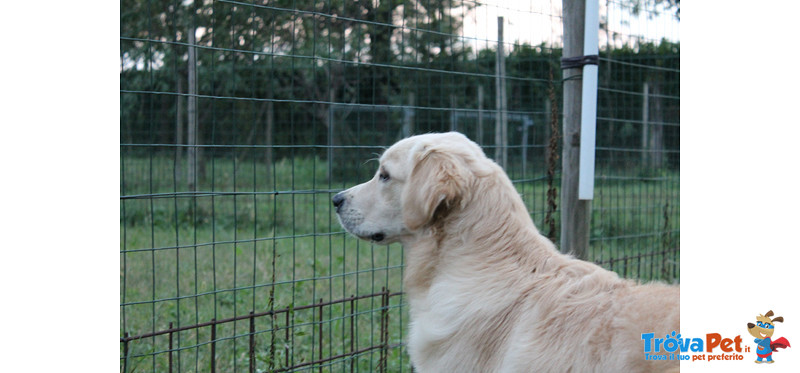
120, 0, 680, 171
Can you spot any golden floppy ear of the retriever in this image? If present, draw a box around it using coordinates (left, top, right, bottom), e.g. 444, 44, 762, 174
402, 146, 471, 231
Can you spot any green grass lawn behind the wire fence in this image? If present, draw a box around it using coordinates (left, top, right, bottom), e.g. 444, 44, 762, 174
120, 154, 680, 372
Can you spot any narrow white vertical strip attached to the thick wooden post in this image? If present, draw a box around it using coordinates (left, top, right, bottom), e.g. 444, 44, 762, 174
578, 0, 600, 200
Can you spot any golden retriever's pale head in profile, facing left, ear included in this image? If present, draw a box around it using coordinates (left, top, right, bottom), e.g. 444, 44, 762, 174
333, 132, 493, 244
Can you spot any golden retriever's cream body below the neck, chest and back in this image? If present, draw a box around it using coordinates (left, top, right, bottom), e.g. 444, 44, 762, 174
409, 234, 680, 372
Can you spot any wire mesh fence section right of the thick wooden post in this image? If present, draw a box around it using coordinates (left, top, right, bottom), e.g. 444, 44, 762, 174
590, 1, 680, 281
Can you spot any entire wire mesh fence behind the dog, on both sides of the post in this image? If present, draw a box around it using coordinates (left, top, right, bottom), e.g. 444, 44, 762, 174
120, 0, 680, 372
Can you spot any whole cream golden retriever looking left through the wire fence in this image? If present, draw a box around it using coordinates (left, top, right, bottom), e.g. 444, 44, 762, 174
333, 132, 680, 373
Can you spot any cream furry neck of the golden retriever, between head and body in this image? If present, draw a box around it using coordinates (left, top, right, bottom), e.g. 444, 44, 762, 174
403, 175, 559, 294
